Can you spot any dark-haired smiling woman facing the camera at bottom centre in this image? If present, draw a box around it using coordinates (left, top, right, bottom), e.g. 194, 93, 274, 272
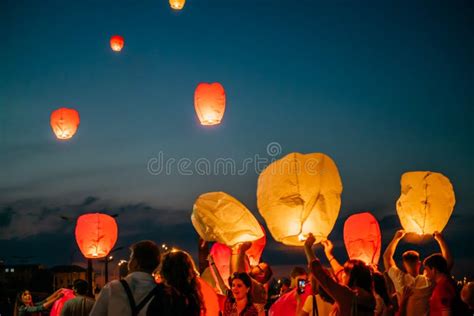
223, 272, 265, 316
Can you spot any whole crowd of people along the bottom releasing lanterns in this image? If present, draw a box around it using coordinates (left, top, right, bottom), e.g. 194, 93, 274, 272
15, 230, 474, 316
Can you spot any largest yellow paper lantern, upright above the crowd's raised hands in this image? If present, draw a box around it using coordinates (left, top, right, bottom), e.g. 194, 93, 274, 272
257, 153, 342, 246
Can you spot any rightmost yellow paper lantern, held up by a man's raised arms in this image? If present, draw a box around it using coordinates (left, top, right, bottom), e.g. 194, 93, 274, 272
397, 171, 456, 235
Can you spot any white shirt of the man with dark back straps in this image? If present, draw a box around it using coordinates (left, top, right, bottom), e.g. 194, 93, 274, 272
90, 272, 156, 316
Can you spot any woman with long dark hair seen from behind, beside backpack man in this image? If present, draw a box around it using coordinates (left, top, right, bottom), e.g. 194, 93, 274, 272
147, 250, 206, 316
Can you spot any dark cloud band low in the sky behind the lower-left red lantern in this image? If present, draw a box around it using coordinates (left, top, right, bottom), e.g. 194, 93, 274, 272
0, 196, 190, 240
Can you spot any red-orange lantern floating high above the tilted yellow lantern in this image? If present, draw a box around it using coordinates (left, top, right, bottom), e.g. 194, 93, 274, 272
194, 82, 225, 125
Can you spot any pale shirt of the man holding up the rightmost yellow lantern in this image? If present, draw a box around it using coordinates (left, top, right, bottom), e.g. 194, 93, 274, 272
388, 266, 433, 316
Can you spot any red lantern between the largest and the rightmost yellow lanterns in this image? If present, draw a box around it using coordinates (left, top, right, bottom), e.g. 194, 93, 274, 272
344, 212, 382, 265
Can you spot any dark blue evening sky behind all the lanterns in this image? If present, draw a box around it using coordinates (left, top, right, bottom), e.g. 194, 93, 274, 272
0, 0, 474, 277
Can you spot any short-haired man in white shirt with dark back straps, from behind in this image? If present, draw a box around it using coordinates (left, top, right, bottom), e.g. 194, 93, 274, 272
90, 240, 161, 316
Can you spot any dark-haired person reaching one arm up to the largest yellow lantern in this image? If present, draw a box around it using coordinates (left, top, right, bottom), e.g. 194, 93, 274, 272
304, 234, 375, 316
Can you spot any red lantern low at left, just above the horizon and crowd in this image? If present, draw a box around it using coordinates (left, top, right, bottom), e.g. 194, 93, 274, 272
76, 213, 118, 259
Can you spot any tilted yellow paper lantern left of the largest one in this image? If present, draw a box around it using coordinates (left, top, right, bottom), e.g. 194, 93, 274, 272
191, 192, 264, 246
